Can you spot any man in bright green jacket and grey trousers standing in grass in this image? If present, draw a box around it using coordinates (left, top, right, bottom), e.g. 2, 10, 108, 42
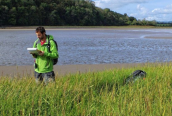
32, 27, 58, 85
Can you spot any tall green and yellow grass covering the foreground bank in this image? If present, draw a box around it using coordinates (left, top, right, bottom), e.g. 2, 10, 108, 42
0, 63, 172, 116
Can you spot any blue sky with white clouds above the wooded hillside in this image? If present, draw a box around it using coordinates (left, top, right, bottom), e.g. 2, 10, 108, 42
93, 0, 172, 21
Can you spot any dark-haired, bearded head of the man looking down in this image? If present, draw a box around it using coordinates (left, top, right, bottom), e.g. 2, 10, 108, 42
36, 27, 46, 40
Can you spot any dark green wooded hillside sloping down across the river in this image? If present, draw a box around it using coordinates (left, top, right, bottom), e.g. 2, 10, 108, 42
0, 0, 156, 26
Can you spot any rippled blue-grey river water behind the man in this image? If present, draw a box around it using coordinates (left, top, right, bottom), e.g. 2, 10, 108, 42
0, 29, 172, 66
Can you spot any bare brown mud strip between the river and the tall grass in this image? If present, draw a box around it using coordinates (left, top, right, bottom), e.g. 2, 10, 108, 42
0, 63, 148, 77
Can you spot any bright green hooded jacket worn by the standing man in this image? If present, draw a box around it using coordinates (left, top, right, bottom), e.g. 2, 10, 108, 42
33, 35, 58, 73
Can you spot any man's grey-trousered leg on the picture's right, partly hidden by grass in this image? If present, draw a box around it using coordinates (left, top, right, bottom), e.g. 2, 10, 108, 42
43, 71, 55, 85
